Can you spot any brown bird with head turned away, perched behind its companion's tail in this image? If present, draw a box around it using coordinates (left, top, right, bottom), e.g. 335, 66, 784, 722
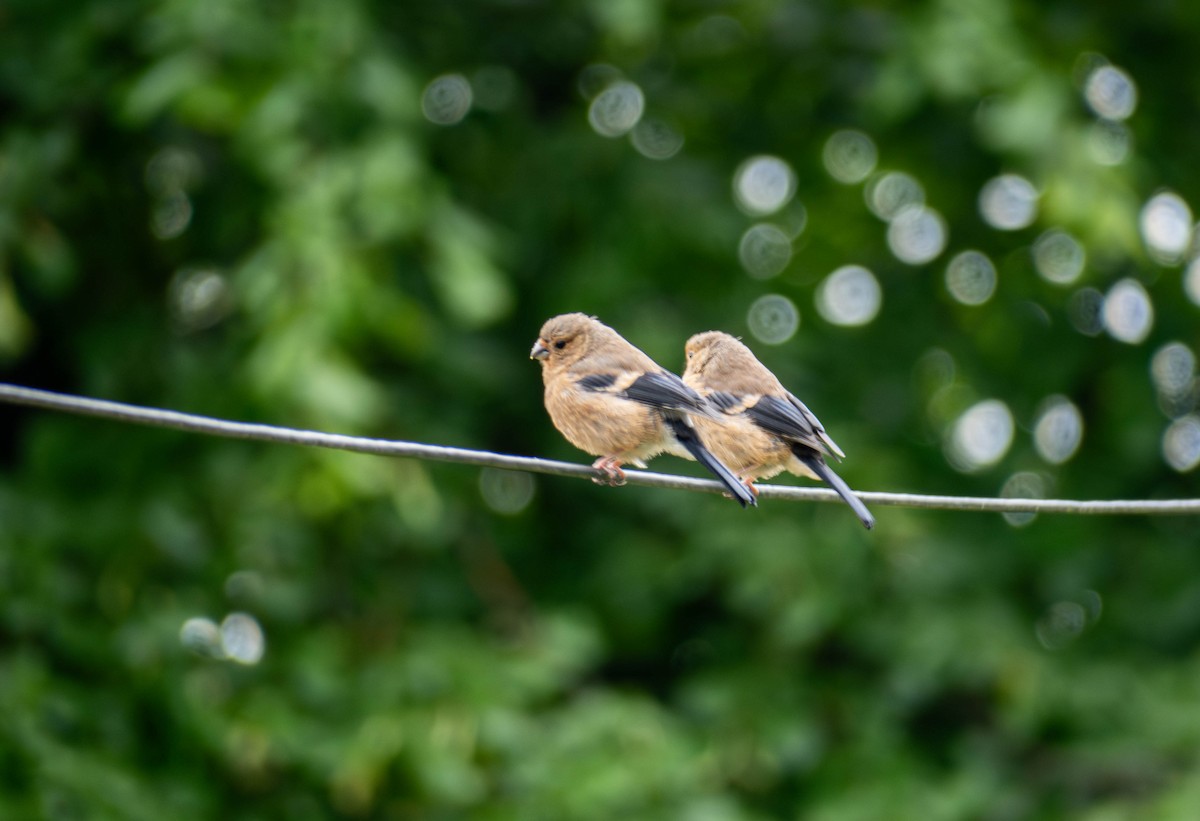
683, 331, 875, 529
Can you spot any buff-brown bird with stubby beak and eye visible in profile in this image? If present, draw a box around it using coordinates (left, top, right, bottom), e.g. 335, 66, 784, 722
529, 313, 757, 508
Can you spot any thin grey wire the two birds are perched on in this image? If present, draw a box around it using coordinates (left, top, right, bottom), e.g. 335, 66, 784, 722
0, 383, 1200, 515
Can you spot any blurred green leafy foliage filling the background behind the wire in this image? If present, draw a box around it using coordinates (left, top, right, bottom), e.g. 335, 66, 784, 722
0, 0, 1200, 821
